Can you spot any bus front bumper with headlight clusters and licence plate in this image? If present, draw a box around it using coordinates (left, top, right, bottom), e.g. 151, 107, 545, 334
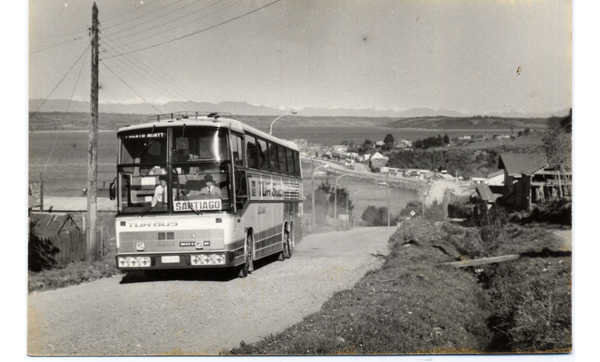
115, 251, 240, 271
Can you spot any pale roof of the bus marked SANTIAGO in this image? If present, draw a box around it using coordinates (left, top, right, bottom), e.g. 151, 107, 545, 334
117, 113, 299, 151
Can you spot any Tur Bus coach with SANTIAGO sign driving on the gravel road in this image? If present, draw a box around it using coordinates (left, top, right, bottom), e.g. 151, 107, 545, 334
110, 112, 303, 278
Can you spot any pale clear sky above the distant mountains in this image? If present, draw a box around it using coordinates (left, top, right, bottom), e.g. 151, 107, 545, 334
29, 0, 572, 113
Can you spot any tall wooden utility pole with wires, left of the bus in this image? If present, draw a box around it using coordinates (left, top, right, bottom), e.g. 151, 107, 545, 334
87, 3, 98, 260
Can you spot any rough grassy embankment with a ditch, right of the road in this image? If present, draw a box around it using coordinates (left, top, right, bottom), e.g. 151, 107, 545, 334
223, 219, 572, 355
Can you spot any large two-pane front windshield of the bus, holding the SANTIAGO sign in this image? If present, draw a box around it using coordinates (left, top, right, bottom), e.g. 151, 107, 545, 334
118, 126, 233, 216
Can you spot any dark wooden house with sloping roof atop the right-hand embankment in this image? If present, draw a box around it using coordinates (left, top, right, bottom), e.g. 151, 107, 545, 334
498, 154, 571, 210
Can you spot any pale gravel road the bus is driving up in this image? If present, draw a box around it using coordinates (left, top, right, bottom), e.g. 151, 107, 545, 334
28, 227, 395, 356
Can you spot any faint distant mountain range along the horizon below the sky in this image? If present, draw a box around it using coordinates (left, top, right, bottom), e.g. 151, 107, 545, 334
29, 99, 569, 118
